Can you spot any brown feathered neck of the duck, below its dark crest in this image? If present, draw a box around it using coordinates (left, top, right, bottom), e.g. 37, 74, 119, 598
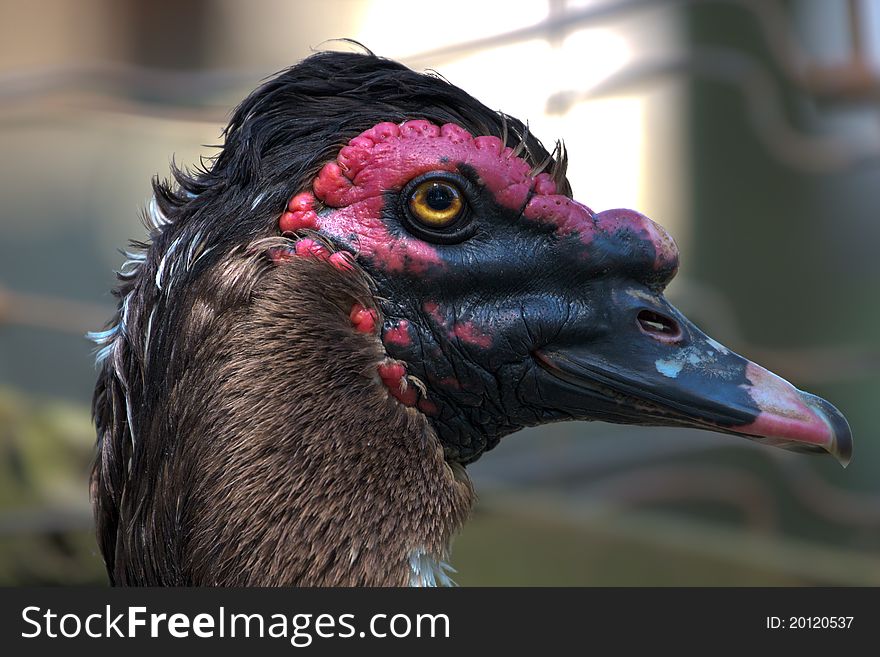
93, 231, 473, 586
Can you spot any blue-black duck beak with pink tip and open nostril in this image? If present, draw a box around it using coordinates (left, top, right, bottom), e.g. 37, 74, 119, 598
534, 297, 852, 467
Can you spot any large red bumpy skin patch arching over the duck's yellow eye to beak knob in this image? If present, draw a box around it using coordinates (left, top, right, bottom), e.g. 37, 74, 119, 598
290, 120, 678, 274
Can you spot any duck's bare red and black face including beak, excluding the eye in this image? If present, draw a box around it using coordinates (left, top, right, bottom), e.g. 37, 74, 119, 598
281, 121, 851, 464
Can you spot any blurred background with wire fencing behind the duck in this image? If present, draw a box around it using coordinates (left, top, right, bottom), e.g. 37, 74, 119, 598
0, 0, 880, 585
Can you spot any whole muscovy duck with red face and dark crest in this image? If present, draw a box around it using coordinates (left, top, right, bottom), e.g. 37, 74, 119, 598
91, 52, 852, 585
